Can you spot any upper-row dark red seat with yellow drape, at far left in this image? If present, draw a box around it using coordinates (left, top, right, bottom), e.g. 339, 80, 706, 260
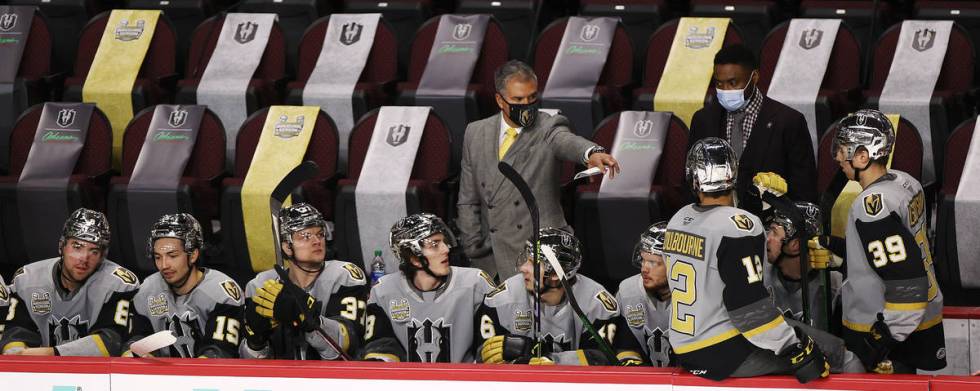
64, 11, 177, 113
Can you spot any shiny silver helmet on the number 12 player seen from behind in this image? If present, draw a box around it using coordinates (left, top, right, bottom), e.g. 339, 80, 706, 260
684, 137, 738, 193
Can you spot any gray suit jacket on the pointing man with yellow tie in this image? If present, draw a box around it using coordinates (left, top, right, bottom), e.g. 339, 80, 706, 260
457, 112, 595, 281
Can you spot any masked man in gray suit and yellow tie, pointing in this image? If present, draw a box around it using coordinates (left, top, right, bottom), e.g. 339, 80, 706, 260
458, 60, 619, 281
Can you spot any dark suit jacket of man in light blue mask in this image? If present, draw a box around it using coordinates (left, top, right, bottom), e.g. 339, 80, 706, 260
687, 97, 817, 202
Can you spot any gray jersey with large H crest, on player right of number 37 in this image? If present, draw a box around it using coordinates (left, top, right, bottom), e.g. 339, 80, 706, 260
363, 266, 494, 363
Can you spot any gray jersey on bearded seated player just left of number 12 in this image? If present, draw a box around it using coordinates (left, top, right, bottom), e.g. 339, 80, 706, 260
616, 274, 673, 367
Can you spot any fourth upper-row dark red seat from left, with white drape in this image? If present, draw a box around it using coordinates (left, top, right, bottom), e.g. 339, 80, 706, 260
286, 16, 398, 120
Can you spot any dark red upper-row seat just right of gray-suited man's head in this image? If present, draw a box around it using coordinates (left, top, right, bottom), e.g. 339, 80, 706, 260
533, 18, 633, 135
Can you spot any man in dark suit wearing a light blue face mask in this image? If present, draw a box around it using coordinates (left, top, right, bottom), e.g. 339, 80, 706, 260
688, 45, 817, 202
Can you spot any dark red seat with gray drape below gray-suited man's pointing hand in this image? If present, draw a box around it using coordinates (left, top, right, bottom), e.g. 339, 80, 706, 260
574, 113, 688, 287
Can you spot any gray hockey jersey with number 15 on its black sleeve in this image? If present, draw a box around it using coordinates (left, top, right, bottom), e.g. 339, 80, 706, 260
130, 268, 245, 358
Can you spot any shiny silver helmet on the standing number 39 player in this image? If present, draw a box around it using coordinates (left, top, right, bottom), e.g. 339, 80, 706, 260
830, 109, 895, 160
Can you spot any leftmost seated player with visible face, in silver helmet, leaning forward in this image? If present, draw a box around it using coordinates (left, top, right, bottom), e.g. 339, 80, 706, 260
0, 208, 139, 356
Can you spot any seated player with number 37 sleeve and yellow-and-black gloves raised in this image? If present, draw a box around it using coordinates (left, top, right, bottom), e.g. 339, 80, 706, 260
239, 203, 368, 360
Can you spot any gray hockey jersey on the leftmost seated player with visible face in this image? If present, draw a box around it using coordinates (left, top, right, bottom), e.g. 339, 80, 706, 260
0, 258, 139, 356
